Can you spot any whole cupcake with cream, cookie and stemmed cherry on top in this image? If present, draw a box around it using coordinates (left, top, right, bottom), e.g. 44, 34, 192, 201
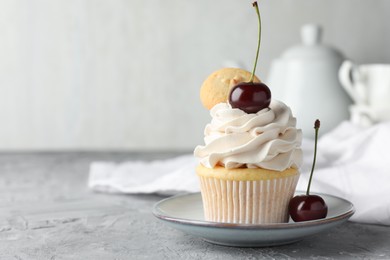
194, 2, 302, 224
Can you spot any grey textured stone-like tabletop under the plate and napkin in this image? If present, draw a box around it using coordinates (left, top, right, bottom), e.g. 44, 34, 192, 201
0, 152, 390, 260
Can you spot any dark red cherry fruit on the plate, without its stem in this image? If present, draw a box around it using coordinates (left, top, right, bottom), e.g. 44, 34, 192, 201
288, 195, 328, 222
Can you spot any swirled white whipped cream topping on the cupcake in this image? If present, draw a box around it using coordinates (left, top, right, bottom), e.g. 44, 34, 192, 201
194, 100, 302, 171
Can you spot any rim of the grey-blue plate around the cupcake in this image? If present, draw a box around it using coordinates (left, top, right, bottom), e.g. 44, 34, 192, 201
152, 191, 355, 230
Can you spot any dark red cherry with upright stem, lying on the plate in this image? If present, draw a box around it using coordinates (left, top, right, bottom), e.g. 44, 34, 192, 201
288, 119, 328, 222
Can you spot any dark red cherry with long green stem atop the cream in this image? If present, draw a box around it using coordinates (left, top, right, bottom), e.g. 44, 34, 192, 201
229, 2, 271, 113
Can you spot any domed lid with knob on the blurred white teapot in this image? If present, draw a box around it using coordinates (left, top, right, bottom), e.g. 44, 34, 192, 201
281, 24, 343, 62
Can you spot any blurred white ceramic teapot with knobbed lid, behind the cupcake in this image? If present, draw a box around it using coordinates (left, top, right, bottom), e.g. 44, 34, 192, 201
267, 24, 352, 138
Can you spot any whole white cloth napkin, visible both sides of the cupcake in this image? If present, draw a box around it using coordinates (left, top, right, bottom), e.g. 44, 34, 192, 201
88, 122, 390, 225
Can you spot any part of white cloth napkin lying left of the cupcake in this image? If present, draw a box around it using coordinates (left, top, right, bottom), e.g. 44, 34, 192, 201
88, 155, 199, 195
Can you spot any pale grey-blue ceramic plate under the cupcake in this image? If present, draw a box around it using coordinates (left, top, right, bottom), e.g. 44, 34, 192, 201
153, 192, 355, 247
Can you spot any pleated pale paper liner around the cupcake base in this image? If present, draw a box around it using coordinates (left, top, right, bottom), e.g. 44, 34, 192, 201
199, 174, 299, 224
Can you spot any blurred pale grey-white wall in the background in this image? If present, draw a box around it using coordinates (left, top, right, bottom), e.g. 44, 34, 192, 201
0, 0, 390, 150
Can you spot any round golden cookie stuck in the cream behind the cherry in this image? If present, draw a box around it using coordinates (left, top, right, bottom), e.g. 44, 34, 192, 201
200, 68, 260, 110
